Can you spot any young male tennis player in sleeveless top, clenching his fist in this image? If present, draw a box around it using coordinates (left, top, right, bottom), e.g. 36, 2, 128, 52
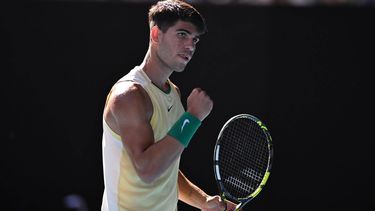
102, 0, 235, 211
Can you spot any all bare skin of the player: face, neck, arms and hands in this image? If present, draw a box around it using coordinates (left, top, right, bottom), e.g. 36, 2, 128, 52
104, 21, 235, 211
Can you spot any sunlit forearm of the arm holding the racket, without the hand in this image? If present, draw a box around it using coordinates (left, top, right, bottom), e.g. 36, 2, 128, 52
178, 171, 209, 208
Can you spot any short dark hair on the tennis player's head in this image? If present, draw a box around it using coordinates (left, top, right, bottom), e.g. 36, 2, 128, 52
148, 0, 207, 34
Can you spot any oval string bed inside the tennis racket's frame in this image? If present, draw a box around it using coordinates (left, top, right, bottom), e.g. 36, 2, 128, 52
219, 118, 269, 198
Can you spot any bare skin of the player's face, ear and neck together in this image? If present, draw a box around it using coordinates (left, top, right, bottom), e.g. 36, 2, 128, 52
143, 21, 200, 89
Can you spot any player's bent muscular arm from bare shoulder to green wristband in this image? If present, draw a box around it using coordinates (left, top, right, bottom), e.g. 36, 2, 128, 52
105, 84, 184, 183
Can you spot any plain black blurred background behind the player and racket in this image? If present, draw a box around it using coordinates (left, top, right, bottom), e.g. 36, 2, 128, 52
0, 0, 375, 211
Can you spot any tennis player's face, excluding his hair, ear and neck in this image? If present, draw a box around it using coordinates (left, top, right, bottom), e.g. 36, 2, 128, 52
158, 21, 199, 72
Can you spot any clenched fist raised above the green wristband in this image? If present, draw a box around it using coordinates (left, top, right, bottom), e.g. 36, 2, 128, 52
187, 88, 213, 121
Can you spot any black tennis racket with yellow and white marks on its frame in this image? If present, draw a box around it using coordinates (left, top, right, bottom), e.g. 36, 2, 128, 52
214, 114, 273, 210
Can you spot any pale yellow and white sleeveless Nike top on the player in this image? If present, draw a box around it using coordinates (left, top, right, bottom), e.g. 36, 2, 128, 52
102, 66, 184, 211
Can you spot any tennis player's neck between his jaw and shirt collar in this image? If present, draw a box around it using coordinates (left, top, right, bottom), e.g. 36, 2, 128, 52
141, 48, 173, 90
